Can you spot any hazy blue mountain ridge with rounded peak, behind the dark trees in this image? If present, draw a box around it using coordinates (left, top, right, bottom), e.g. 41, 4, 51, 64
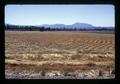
40, 22, 94, 29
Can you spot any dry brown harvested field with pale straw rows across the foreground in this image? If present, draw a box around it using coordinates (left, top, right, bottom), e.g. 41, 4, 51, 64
5, 31, 115, 79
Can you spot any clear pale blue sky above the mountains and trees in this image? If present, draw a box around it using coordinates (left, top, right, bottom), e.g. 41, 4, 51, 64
5, 4, 115, 26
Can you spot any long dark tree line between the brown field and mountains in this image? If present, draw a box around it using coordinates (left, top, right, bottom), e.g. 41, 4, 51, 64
5, 24, 114, 32
